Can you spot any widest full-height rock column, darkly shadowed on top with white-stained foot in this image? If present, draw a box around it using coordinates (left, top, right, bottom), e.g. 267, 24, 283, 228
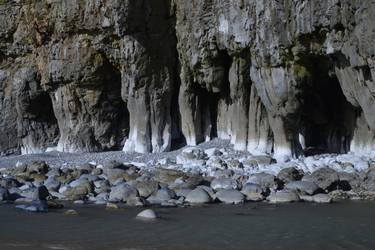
119, 0, 177, 153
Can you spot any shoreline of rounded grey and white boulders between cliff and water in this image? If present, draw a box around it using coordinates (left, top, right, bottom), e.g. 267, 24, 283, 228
0, 141, 375, 208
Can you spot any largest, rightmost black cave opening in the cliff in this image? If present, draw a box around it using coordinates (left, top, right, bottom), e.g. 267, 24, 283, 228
299, 57, 356, 156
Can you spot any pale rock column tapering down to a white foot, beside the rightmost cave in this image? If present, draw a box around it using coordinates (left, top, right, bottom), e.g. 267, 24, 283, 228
250, 66, 304, 161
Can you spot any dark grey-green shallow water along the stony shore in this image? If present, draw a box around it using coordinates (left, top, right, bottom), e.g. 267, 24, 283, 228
0, 202, 375, 250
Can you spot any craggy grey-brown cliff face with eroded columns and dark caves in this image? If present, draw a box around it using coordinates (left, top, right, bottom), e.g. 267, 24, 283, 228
0, 0, 375, 161
